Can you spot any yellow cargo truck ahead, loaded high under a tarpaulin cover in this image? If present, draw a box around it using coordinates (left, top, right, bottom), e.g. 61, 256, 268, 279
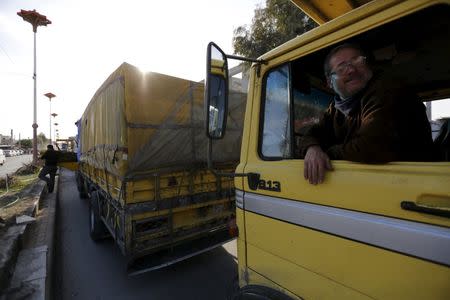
76, 63, 245, 274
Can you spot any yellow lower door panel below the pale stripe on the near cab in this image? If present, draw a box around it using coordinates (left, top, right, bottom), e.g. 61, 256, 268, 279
246, 213, 450, 299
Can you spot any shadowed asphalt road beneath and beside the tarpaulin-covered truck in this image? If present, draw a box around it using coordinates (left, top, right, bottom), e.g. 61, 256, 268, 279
55, 170, 237, 300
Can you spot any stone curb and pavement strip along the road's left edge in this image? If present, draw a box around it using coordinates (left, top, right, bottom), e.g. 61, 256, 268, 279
0, 176, 59, 300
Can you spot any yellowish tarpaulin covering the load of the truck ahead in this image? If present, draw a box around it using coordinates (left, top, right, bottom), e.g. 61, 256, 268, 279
80, 63, 246, 178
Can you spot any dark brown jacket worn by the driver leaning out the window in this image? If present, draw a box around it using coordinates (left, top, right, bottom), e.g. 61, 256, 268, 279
300, 79, 433, 163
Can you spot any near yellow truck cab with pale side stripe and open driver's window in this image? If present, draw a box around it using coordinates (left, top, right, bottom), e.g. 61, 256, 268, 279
205, 0, 450, 300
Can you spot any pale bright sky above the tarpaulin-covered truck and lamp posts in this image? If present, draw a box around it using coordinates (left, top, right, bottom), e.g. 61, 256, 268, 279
0, 0, 265, 139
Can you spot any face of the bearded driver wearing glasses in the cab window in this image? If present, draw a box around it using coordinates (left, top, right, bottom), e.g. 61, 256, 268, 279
328, 48, 372, 99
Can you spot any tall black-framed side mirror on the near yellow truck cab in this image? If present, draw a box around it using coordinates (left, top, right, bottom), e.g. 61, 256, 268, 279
205, 42, 228, 139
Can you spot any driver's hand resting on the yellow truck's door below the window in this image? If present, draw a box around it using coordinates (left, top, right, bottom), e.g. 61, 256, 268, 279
303, 145, 333, 184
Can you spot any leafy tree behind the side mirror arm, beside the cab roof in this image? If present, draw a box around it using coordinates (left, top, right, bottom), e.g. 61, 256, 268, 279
233, 0, 316, 58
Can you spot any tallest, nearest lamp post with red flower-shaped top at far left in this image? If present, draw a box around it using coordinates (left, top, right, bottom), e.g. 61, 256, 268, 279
17, 9, 52, 163
